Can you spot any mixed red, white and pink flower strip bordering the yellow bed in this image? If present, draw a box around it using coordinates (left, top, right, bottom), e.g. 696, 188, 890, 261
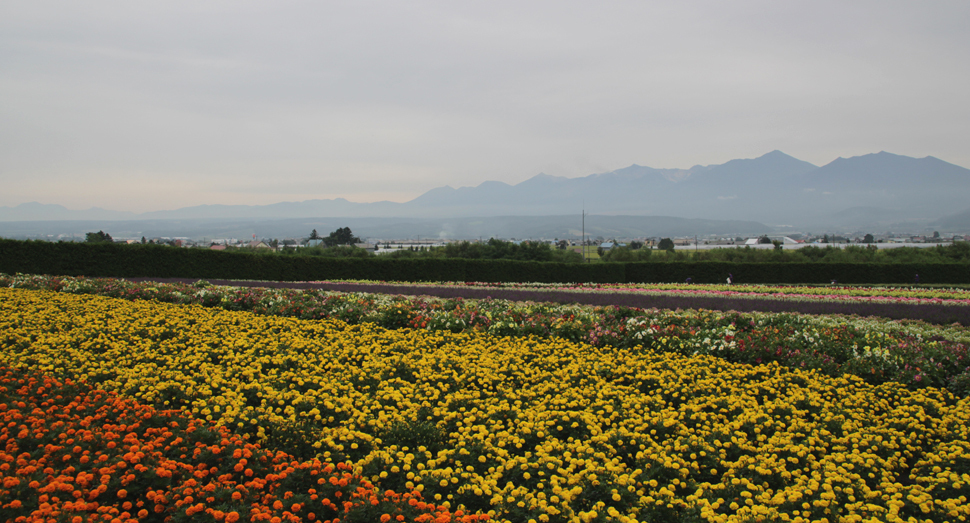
0, 276, 970, 396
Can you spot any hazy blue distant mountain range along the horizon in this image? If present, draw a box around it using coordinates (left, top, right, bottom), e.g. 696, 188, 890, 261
0, 150, 970, 230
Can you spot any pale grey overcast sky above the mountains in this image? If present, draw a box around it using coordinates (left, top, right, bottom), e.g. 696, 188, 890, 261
0, 0, 970, 211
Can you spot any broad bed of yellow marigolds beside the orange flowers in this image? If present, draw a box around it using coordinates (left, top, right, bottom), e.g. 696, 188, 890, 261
0, 289, 970, 522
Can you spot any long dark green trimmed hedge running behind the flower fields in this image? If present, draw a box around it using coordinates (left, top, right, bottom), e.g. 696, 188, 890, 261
0, 240, 970, 284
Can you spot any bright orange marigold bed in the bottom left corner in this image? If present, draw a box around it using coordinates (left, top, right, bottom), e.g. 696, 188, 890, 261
0, 369, 488, 523
